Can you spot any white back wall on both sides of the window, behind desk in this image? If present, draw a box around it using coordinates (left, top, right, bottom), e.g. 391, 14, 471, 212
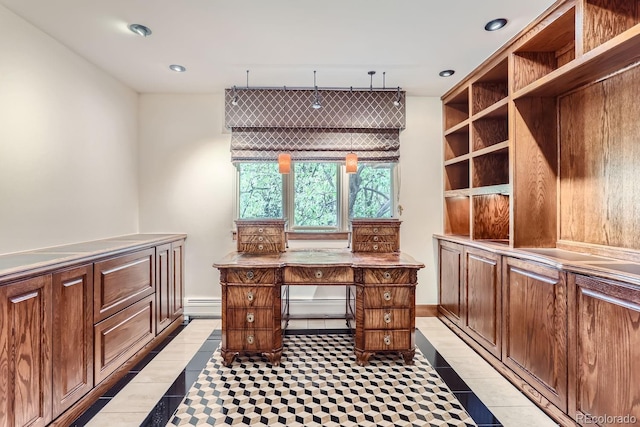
139, 94, 442, 315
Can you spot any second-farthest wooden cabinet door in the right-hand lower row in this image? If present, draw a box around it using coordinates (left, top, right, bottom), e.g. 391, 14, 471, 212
463, 248, 502, 359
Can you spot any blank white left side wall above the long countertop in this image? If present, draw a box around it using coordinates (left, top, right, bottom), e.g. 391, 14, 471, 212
0, 6, 138, 253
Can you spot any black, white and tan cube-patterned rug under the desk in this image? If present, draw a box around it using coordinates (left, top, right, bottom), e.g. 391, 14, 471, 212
168, 335, 476, 427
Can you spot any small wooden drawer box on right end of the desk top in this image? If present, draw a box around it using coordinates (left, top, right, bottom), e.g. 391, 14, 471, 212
351, 219, 400, 253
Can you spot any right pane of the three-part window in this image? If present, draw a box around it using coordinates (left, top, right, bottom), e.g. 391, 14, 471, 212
349, 163, 393, 218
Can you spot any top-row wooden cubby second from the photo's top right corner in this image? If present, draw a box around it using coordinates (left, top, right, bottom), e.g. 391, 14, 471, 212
513, 7, 576, 91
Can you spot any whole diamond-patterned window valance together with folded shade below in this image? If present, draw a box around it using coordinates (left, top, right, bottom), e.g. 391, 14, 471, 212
225, 89, 405, 162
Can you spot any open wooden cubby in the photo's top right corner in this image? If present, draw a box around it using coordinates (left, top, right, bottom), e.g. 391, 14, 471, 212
583, 0, 640, 52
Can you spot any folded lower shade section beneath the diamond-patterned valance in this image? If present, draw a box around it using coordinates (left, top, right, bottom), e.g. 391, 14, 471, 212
231, 128, 400, 162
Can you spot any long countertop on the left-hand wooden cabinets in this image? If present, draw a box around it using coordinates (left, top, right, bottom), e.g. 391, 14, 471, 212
0, 234, 186, 282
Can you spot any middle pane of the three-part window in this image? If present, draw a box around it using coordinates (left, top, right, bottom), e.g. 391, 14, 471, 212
294, 162, 338, 227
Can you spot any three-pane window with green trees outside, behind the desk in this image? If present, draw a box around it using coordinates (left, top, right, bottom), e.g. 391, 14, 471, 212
236, 162, 396, 231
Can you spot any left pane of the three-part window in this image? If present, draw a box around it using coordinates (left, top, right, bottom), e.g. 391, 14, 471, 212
238, 163, 282, 219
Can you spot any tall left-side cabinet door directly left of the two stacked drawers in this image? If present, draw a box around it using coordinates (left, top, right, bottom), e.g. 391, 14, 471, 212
53, 265, 93, 418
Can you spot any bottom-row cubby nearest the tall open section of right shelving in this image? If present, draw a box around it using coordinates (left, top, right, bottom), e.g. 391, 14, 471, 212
472, 194, 509, 240
